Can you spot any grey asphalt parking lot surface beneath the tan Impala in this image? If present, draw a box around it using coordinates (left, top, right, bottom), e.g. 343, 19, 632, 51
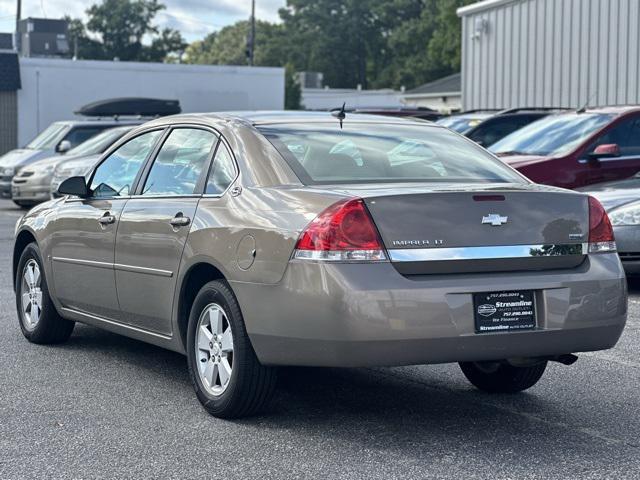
0, 197, 640, 479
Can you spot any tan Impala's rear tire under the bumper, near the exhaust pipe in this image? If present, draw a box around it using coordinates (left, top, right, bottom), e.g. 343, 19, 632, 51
460, 361, 547, 393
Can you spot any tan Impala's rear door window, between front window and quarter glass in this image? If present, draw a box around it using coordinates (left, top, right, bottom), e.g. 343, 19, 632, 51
142, 128, 218, 195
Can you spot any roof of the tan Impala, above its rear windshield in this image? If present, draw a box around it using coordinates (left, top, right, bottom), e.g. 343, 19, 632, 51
142, 110, 433, 126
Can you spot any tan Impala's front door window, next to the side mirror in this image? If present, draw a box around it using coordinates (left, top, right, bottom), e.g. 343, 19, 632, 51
89, 130, 162, 198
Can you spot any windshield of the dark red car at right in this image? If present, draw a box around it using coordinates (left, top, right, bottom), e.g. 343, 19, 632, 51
489, 113, 613, 157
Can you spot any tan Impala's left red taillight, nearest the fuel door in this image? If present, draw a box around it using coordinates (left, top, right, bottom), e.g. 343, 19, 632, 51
294, 198, 386, 262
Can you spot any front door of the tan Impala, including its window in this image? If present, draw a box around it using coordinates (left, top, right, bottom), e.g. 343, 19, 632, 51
51, 131, 161, 320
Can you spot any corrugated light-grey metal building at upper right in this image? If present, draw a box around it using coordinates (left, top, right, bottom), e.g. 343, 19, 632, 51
458, 0, 640, 110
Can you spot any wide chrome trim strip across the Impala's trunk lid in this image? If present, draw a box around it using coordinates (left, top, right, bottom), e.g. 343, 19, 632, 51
388, 243, 589, 262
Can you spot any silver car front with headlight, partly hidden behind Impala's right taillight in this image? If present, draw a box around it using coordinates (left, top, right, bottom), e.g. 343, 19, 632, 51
580, 174, 640, 275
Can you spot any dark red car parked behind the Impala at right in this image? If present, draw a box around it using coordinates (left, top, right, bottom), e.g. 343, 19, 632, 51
489, 107, 640, 188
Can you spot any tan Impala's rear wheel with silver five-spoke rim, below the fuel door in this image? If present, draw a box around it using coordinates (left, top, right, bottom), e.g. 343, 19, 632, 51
187, 281, 276, 418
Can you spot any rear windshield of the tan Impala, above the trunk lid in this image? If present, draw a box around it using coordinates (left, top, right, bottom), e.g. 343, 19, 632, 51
258, 120, 524, 184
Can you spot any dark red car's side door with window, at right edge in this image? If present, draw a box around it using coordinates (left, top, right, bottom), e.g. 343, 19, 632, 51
582, 116, 640, 183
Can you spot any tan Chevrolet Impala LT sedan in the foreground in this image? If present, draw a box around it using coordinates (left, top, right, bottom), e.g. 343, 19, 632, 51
13, 112, 627, 418
